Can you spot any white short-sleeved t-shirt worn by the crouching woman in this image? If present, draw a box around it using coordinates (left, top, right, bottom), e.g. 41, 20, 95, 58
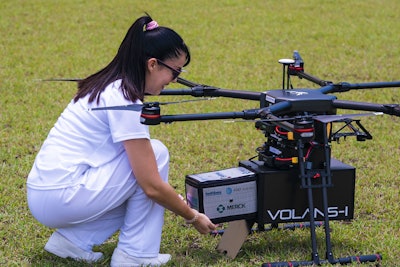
27, 80, 150, 189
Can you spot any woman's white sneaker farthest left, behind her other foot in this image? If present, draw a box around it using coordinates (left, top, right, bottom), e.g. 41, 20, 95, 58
44, 232, 103, 263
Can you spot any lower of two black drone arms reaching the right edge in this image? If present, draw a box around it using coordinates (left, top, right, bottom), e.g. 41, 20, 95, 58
332, 100, 400, 117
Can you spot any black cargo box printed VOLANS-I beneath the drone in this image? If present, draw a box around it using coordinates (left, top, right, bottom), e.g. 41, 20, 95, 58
239, 159, 355, 225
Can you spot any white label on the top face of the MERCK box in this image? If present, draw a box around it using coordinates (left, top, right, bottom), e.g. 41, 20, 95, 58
191, 167, 254, 183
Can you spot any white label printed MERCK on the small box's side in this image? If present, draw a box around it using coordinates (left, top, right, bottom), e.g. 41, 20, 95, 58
203, 181, 257, 219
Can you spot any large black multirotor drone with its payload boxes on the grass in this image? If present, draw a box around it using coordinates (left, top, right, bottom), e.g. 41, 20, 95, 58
47, 51, 400, 267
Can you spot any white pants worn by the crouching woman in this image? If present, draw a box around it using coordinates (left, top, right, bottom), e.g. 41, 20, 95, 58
28, 139, 169, 257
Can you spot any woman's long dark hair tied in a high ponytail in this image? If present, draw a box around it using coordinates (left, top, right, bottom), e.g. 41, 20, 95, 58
74, 14, 190, 102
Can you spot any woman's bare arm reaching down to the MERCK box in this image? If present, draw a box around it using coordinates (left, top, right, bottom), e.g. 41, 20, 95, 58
124, 138, 215, 234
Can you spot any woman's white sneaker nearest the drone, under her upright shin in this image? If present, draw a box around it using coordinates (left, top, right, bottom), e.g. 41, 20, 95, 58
111, 248, 171, 267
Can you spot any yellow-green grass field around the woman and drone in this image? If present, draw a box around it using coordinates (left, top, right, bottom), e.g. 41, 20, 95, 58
0, 0, 400, 266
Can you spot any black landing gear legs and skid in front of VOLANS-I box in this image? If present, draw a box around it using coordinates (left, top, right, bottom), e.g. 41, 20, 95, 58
262, 124, 382, 267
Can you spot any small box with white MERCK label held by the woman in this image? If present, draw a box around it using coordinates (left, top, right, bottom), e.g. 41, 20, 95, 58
185, 167, 257, 223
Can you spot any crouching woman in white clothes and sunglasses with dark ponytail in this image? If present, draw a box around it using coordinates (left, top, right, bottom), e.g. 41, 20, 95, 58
27, 15, 215, 266
